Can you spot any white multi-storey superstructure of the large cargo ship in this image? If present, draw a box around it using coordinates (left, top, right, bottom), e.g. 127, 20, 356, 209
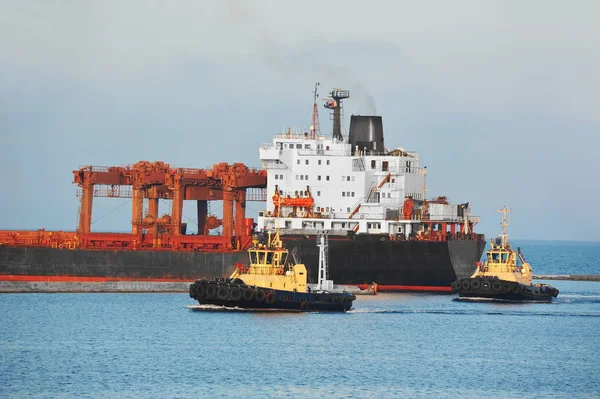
257, 90, 478, 238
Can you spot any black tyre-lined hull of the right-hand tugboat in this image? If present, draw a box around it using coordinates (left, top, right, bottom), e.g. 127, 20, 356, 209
452, 277, 559, 302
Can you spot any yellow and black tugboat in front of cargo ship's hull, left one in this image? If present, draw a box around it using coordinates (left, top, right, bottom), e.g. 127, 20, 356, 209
190, 229, 356, 312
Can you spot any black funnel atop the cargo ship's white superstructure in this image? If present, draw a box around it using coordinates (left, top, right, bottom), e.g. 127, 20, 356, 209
348, 115, 385, 155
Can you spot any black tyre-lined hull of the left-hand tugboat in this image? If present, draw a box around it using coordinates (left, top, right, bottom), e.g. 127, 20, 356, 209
190, 279, 356, 312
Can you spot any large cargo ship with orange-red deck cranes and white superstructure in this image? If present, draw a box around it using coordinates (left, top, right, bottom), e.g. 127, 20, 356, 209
0, 86, 485, 292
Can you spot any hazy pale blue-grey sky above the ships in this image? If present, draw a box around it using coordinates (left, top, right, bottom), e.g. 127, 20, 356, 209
0, 0, 600, 241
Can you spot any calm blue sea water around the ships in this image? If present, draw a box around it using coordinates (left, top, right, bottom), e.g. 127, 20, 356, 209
0, 242, 600, 398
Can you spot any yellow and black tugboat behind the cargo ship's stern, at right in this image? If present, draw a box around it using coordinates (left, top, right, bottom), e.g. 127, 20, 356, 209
451, 205, 558, 302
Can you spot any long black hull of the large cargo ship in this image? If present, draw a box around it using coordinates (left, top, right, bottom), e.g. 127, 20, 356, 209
0, 235, 485, 292
